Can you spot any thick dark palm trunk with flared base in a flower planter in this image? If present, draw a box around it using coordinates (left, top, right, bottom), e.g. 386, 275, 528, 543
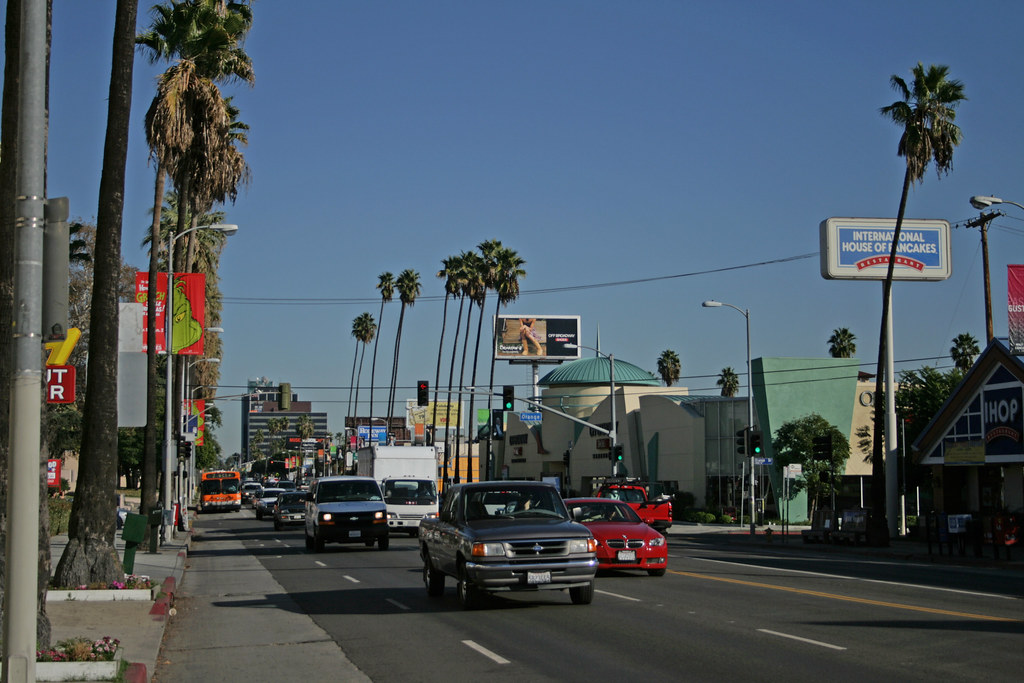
54, 0, 138, 586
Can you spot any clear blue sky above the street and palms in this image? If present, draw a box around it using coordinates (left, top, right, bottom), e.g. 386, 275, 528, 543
25, 0, 1024, 453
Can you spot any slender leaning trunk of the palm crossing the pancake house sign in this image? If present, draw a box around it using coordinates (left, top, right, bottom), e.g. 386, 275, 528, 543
871, 163, 910, 546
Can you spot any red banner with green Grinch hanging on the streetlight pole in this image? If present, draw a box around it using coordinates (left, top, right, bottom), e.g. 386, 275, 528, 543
135, 272, 206, 355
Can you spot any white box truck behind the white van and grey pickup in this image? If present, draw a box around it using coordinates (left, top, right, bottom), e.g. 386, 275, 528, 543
356, 445, 437, 536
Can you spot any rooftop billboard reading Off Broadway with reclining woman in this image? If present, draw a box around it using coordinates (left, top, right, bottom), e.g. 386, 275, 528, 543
495, 314, 580, 360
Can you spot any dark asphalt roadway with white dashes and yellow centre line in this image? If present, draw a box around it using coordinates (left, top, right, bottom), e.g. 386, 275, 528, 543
160, 511, 1024, 683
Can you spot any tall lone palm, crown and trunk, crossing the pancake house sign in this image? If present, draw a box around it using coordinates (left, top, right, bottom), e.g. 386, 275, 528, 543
871, 61, 966, 545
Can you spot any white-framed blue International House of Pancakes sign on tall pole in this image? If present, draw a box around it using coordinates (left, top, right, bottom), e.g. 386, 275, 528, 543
818, 218, 952, 281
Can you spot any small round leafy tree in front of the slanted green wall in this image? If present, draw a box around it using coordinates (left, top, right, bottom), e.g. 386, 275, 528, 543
772, 413, 850, 516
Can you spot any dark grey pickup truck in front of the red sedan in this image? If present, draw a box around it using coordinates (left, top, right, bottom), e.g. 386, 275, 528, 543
420, 481, 597, 609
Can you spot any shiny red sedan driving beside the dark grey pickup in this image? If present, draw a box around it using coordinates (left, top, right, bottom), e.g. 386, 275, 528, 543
565, 498, 669, 577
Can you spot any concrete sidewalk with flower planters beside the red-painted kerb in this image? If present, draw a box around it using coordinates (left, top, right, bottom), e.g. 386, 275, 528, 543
46, 529, 191, 683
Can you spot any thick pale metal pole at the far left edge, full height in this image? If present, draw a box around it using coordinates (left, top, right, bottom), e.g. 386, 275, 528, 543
2, 0, 47, 682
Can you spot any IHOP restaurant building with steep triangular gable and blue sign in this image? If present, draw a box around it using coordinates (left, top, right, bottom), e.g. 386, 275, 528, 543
913, 339, 1024, 514
